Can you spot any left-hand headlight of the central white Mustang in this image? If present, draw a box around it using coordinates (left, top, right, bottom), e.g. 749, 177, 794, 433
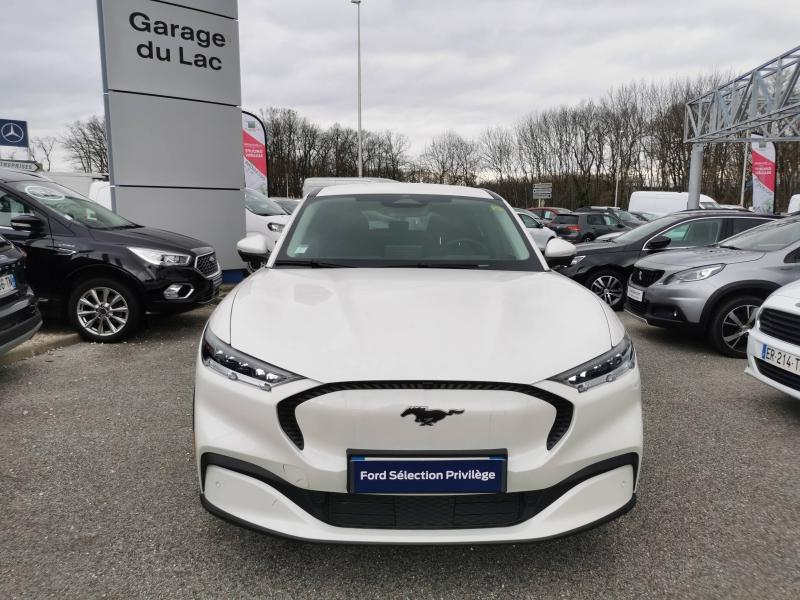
200, 327, 302, 391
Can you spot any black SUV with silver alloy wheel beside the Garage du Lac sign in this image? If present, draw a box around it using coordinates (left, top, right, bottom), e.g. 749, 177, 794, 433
0, 169, 222, 342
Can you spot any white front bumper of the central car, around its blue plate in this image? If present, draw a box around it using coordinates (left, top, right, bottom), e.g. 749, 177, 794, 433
195, 360, 642, 544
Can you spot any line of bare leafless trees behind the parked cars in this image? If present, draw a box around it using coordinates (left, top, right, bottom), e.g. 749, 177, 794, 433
50, 73, 800, 209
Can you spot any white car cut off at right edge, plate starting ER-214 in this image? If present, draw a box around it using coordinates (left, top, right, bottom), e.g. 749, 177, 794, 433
745, 281, 800, 400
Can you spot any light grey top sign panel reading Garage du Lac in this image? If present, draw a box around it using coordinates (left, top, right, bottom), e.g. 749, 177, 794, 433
100, 0, 241, 105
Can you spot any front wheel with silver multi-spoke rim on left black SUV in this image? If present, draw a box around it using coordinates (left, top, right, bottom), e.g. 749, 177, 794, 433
67, 277, 143, 343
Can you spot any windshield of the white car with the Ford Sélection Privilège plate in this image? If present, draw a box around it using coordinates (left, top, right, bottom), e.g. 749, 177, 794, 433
275, 194, 542, 271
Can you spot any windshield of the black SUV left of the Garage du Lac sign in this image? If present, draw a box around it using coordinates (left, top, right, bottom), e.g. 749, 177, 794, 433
8, 181, 138, 229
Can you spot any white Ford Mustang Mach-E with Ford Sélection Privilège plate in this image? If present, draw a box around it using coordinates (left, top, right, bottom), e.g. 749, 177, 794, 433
194, 184, 642, 544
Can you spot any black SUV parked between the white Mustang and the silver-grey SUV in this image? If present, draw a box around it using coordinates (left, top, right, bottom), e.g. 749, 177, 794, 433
559, 209, 778, 310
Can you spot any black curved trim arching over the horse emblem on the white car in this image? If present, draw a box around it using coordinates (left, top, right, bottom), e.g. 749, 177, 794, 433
278, 381, 573, 450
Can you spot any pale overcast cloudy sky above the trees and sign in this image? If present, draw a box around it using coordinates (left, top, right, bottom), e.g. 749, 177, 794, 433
0, 0, 800, 168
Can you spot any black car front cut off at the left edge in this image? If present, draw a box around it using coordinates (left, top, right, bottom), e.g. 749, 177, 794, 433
0, 236, 42, 354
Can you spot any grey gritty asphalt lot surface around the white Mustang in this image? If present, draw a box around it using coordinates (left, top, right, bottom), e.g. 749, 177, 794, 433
0, 309, 800, 599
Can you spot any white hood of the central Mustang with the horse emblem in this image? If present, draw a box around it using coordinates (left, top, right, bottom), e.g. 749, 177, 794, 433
225, 268, 611, 383
